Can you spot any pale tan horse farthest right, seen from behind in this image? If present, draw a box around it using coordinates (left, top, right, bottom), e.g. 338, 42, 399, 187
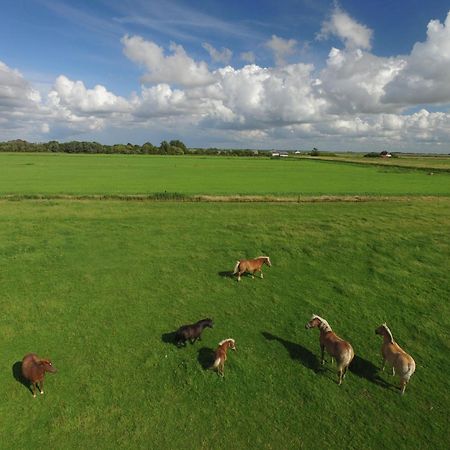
375, 323, 416, 395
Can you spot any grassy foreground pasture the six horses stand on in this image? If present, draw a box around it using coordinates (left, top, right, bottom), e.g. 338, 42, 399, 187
0, 198, 450, 449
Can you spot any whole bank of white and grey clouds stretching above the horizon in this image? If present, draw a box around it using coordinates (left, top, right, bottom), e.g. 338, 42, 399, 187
0, 9, 450, 150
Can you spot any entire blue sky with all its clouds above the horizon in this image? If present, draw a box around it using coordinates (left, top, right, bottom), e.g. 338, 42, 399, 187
0, 0, 450, 154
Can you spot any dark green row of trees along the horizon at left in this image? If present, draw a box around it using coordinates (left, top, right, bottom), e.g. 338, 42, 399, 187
0, 139, 271, 156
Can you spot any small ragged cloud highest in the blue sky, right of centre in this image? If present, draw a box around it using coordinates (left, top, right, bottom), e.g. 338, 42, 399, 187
317, 7, 373, 50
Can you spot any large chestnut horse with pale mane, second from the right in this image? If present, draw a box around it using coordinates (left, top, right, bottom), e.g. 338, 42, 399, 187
305, 314, 355, 385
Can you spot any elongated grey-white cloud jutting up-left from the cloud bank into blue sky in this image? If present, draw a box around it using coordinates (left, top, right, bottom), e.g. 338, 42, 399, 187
121, 35, 213, 87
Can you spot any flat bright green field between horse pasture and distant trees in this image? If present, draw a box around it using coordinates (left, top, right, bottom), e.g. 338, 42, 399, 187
0, 153, 450, 196
